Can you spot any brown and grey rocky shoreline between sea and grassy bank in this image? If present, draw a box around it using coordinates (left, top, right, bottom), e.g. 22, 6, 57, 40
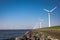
15, 31, 58, 40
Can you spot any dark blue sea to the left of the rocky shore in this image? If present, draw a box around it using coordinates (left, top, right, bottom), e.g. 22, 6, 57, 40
0, 29, 30, 40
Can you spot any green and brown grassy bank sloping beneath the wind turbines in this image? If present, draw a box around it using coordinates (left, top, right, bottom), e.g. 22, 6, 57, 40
34, 26, 60, 40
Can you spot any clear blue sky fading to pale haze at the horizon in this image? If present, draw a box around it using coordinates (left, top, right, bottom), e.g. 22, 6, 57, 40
0, 0, 60, 29
